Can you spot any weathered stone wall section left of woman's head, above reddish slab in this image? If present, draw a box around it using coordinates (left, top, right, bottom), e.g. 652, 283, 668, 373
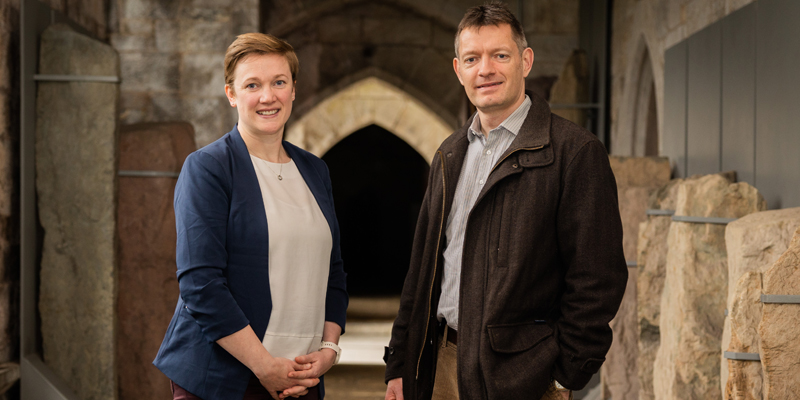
109, 0, 259, 146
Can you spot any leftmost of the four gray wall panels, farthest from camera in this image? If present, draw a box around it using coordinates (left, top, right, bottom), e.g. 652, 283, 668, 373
661, 41, 688, 178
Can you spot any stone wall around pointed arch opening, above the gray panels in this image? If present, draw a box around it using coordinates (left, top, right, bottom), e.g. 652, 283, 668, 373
610, 0, 754, 156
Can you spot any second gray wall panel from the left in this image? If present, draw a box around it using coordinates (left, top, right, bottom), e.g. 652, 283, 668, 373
686, 22, 722, 175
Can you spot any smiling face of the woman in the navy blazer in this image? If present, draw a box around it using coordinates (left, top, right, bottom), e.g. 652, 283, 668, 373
225, 54, 294, 141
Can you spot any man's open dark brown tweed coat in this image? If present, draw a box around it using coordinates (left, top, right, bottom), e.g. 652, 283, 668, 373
384, 93, 627, 400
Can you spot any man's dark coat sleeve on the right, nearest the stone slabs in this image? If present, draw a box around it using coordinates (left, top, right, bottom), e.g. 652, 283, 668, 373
553, 140, 628, 390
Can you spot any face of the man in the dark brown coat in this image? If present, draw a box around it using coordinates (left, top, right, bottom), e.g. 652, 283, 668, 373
453, 24, 533, 113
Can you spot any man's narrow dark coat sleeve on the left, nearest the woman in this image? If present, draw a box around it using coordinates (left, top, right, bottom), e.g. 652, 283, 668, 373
383, 155, 439, 383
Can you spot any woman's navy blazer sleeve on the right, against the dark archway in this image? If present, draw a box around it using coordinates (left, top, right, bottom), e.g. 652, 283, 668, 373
321, 162, 349, 333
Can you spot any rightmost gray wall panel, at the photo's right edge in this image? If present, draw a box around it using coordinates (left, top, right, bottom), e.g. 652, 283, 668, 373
756, 0, 800, 208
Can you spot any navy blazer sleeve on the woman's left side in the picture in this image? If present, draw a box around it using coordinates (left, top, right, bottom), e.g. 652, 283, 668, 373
175, 152, 250, 342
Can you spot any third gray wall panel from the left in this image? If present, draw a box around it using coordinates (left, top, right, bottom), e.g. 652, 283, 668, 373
722, 3, 757, 185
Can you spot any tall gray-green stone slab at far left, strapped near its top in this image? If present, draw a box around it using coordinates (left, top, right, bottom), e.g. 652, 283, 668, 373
36, 25, 119, 399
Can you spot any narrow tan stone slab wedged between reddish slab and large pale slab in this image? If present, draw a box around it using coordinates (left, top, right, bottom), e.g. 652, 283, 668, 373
636, 179, 683, 400
